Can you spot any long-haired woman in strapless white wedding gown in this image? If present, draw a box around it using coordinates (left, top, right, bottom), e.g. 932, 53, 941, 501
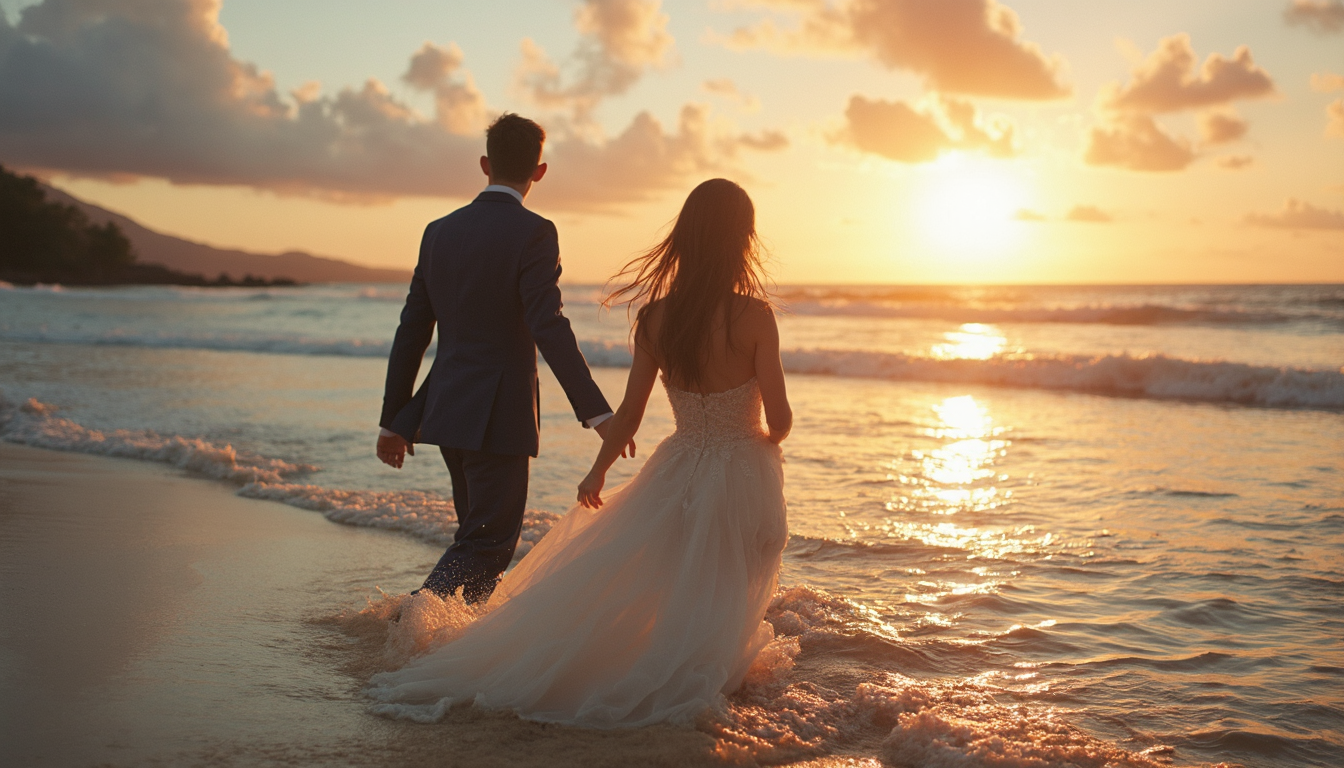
371, 179, 793, 728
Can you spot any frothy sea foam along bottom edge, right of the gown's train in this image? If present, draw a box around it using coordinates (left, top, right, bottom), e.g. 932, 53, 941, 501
703, 586, 1167, 768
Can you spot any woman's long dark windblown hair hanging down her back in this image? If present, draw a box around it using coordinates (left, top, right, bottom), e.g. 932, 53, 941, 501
603, 179, 769, 387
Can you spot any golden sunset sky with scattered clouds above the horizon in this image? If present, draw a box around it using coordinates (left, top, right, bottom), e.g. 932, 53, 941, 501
0, 0, 1344, 284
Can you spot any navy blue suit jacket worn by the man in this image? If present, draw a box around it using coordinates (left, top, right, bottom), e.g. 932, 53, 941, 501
379, 192, 612, 456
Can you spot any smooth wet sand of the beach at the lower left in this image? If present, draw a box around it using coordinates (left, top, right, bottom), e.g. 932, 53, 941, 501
0, 444, 741, 768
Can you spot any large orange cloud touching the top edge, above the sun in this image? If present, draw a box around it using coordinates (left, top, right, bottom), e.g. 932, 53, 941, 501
726, 0, 1070, 100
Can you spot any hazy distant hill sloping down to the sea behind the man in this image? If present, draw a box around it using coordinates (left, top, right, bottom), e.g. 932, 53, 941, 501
42, 184, 411, 282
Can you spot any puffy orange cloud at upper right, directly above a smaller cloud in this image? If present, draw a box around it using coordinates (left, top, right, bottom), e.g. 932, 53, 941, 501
1106, 34, 1277, 114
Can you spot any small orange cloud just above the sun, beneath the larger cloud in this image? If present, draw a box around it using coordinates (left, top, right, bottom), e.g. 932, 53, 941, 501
831, 95, 1013, 163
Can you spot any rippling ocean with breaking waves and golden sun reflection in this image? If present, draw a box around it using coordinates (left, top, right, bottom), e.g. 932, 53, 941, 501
0, 285, 1344, 768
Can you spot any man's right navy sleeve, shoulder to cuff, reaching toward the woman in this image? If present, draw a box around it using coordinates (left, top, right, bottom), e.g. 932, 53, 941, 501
519, 222, 612, 426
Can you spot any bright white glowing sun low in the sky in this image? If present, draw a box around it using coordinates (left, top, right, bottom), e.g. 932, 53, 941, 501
918, 152, 1027, 256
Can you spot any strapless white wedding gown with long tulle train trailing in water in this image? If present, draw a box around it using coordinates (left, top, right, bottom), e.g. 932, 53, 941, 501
370, 379, 788, 728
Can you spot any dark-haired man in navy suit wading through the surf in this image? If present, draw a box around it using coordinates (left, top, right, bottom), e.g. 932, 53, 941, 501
378, 113, 634, 603
